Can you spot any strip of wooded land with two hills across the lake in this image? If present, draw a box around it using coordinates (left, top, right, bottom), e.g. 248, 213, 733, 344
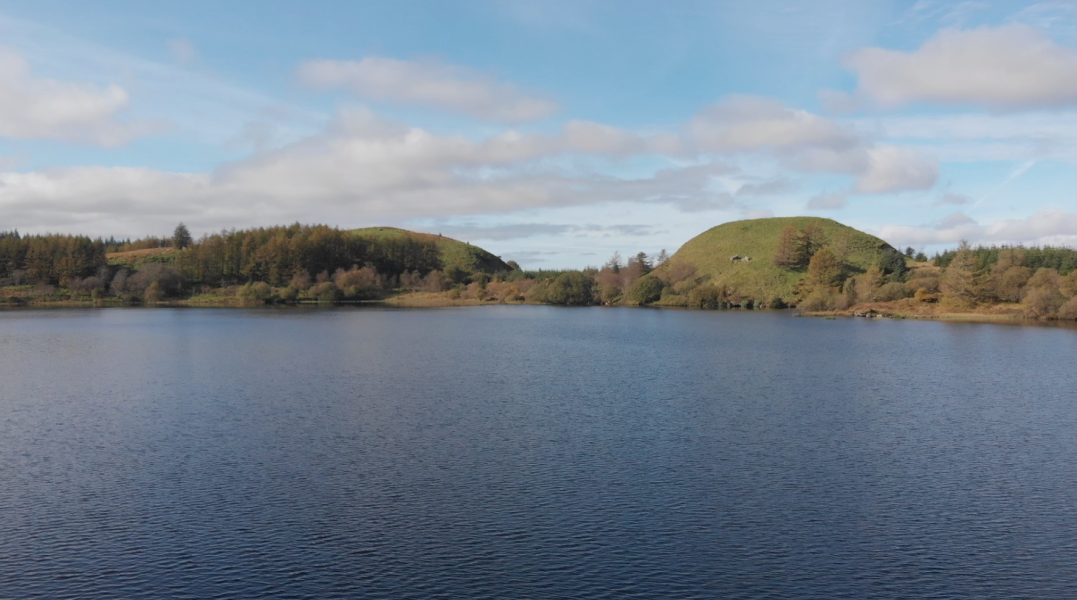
0, 217, 1077, 320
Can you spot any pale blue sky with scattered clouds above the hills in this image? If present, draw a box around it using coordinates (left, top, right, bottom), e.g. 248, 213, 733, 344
0, 0, 1077, 268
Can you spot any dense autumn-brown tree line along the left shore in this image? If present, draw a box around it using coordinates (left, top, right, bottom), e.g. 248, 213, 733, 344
0, 223, 454, 301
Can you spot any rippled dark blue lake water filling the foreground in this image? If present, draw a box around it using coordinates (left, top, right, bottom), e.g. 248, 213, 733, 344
0, 306, 1077, 599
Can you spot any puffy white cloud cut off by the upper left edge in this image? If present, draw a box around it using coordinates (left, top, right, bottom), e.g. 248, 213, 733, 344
0, 44, 146, 146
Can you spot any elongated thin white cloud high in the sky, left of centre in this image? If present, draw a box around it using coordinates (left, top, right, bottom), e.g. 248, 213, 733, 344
298, 57, 557, 123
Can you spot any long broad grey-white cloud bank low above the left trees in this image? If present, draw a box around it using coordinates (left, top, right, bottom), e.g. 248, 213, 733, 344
0, 110, 732, 235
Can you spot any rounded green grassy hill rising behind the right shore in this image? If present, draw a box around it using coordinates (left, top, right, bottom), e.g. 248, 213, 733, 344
656, 217, 895, 302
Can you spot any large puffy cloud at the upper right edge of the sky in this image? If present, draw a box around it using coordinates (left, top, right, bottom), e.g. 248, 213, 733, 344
828, 24, 1077, 110
